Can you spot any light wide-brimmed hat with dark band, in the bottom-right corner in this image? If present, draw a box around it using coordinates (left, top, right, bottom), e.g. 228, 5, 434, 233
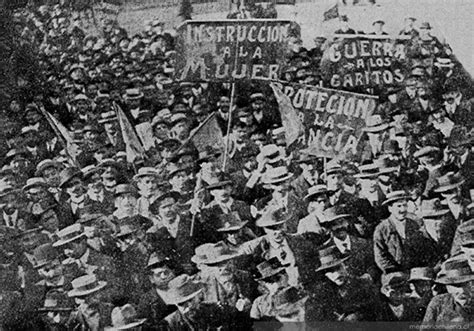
436, 255, 474, 285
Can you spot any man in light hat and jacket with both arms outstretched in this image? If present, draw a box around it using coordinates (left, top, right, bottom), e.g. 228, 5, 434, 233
240, 208, 330, 286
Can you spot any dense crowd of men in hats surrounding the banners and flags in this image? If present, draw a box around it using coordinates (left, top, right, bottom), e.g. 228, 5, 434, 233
0, 1, 474, 330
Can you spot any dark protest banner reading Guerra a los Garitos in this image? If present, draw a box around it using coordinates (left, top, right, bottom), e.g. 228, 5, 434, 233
321, 35, 409, 90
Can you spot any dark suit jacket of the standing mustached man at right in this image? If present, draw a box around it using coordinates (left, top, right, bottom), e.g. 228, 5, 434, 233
374, 218, 434, 273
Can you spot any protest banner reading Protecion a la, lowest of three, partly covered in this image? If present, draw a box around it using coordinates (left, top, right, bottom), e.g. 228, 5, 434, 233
278, 83, 377, 158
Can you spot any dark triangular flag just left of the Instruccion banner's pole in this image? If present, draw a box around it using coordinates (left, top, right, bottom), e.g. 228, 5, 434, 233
188, 113, 224, 152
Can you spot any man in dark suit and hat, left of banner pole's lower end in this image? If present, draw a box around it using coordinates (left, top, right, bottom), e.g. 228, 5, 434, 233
146, 191, 194, 270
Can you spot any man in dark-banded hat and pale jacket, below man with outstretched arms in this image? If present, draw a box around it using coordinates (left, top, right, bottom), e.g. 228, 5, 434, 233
250, 258, 288, 320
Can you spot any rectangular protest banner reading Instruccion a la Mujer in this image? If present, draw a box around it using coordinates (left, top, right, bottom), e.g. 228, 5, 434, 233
175, 19, 294, 81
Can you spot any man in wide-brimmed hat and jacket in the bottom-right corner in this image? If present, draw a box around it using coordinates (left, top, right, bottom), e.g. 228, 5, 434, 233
423, 257, 474, 325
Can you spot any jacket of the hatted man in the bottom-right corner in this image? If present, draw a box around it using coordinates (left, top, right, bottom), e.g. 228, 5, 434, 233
423, 293, 474, 324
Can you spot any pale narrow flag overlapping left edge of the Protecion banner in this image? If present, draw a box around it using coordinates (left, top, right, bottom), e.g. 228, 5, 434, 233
270, 83, 304, 146
